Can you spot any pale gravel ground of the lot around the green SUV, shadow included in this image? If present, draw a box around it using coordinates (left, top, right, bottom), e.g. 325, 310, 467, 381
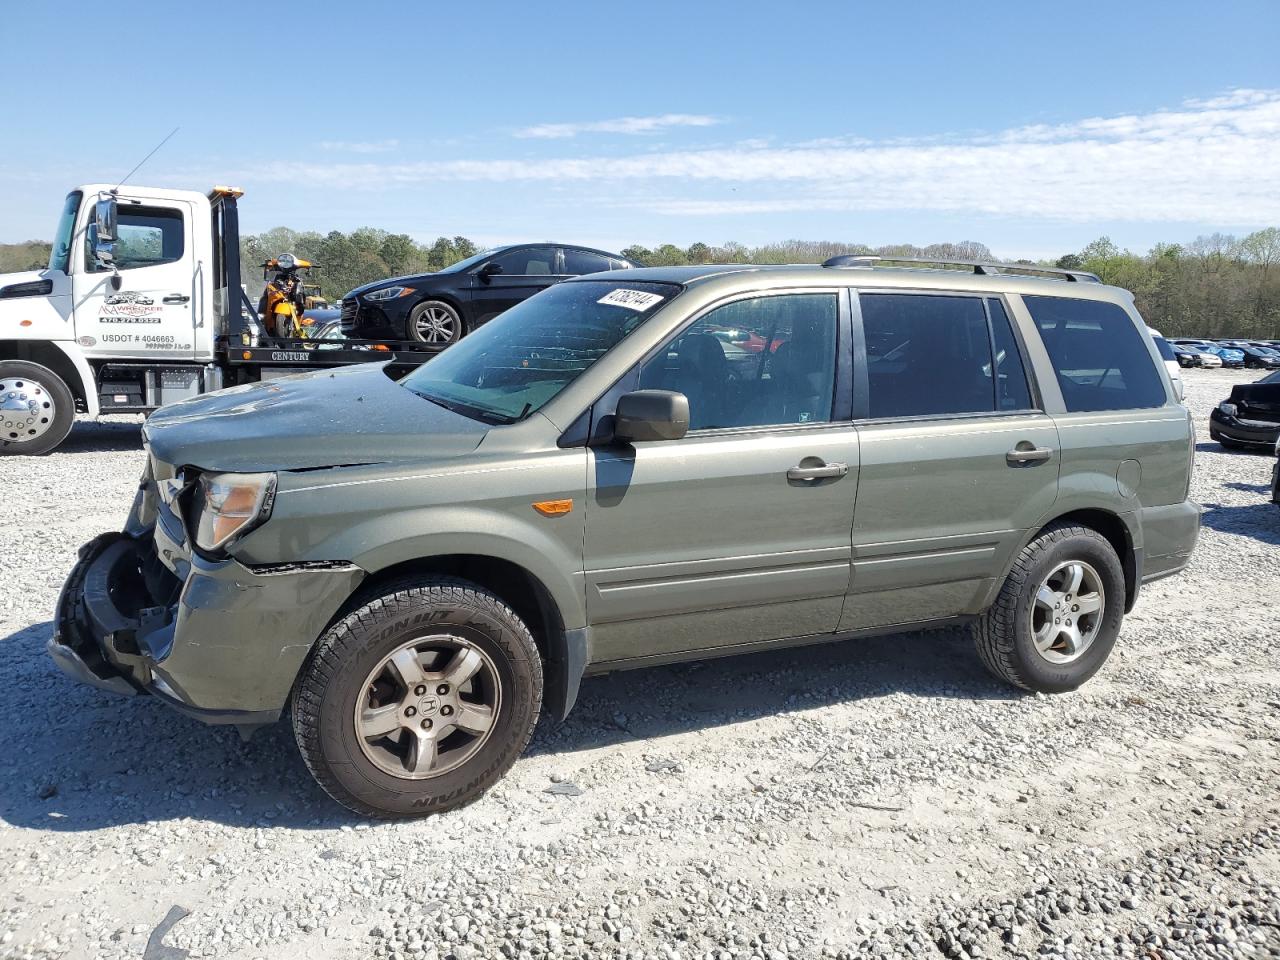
0, 370, 1280, 960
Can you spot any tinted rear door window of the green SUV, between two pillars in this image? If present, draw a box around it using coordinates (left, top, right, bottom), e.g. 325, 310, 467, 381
859, 293, 1032, 419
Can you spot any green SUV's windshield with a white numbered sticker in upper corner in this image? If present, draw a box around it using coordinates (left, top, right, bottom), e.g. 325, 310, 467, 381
401, 280, 681, 424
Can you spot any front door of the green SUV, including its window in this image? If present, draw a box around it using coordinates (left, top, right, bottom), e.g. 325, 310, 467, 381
585, 292, 858, 660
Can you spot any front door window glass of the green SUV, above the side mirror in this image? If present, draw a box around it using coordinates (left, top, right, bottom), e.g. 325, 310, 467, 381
640, 293, 838, 430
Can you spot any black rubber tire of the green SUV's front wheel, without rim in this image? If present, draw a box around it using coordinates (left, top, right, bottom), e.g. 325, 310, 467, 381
292, 577, 543, 818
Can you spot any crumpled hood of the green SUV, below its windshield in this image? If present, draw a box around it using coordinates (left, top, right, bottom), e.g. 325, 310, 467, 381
143, 364, 489, 472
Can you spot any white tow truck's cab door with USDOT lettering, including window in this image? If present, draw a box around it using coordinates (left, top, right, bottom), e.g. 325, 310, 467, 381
72, 196, 198, 360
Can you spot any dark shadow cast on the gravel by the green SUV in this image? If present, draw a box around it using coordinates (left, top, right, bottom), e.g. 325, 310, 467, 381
0, 623, 1019, 832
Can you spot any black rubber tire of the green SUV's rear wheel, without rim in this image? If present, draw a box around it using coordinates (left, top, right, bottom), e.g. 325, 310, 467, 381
973, 524, 1125, 694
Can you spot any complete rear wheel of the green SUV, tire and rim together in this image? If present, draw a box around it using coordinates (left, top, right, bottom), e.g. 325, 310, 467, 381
973, 525, 1125, 694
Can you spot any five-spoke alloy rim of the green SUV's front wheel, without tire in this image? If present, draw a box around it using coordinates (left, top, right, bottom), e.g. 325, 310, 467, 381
355, 635, 502, 780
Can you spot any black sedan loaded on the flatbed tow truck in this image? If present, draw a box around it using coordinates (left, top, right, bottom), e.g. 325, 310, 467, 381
342, 243, 640, 346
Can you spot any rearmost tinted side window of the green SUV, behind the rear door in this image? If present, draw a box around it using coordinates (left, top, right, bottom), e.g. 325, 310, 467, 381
1023, 297, 1165, 412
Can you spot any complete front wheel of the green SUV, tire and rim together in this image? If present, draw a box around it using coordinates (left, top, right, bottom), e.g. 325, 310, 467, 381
293, 577, 543, 817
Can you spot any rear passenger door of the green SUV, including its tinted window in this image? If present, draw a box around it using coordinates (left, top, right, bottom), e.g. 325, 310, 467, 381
840, 291, 1060, 640
